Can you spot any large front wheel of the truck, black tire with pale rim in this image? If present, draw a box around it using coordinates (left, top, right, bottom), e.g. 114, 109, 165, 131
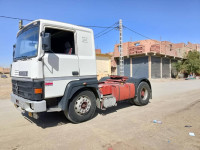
64, 90, 96, 123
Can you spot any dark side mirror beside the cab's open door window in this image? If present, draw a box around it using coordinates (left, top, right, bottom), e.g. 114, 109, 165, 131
42, 32, 51, 51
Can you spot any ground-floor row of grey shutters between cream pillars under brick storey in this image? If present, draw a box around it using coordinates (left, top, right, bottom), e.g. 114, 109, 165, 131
115, 55, 177, 79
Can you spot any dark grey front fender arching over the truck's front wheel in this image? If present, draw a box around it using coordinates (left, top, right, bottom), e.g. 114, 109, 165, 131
58, 78, 100, 110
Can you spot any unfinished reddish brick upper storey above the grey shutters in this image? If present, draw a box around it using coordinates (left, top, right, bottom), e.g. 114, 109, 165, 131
113, 39, 200, 58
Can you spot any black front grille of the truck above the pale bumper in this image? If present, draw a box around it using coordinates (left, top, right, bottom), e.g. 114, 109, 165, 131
12, 80, 44, 101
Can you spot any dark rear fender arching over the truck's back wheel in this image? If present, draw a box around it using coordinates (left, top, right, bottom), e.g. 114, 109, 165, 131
126, 77, 152, 99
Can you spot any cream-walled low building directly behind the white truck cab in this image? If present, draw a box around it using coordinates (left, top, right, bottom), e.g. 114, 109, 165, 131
96, 49, 111, 80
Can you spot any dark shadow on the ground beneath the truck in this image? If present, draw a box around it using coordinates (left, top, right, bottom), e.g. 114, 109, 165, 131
22, 102, 133, 129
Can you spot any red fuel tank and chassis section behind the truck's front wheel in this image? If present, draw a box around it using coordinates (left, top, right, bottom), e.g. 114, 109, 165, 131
99, 77, 135, 101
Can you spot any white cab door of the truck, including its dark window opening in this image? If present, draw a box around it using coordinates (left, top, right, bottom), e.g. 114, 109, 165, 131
43, 27, 79, 98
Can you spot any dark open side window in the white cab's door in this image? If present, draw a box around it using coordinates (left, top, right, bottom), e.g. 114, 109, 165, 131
45, 28, 75, 55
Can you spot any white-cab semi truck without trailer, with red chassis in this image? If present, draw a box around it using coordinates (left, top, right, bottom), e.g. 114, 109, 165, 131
11, 19, 152, 123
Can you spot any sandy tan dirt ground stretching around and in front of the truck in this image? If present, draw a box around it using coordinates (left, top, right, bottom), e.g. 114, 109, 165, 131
0, 80, 200, 150
